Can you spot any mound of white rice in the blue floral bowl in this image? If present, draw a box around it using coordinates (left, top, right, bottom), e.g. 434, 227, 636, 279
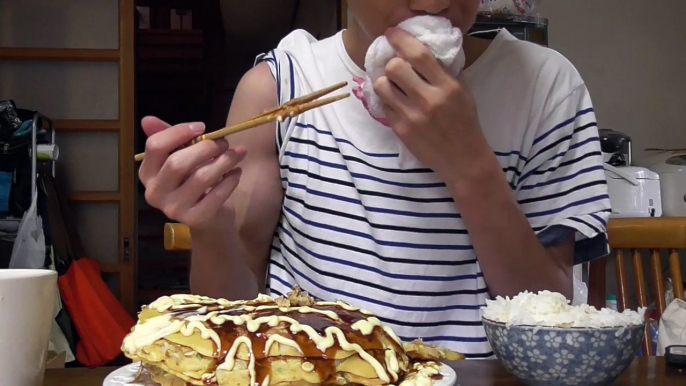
483, 291, 646, 328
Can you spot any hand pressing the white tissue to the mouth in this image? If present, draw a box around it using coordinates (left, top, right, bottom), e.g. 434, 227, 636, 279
374, 28, 492, 182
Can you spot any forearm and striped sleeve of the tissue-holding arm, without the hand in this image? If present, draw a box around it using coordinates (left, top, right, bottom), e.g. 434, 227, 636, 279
448, 84, 610, 300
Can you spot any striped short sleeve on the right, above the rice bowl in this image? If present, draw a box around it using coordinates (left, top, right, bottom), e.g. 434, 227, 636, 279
516, 85, 611, 265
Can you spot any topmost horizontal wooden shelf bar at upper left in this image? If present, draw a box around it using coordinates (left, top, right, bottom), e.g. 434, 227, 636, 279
0, 47, 119, 62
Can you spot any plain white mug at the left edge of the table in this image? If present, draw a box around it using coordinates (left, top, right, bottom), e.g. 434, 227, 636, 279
0, 269, 57, 386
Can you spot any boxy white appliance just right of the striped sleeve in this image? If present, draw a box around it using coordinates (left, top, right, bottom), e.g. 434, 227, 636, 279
604, 164, 662, 218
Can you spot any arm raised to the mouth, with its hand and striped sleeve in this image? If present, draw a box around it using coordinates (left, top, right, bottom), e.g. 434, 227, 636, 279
374, 28, 609, 300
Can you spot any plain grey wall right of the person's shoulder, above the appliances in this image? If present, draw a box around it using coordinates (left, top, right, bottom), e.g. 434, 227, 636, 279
541, 0, 686, 159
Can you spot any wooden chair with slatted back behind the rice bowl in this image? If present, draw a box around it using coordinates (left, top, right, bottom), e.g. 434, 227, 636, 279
589, 218, 686, 355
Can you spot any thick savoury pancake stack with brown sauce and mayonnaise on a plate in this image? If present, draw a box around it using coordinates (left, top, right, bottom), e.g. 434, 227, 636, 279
122, 288, 464, 386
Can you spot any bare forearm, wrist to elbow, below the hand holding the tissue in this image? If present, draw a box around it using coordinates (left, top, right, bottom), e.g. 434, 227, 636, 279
447, 146, 575, 300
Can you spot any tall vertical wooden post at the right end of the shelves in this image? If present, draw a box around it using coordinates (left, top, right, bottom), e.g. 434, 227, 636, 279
119, 0, 138, 315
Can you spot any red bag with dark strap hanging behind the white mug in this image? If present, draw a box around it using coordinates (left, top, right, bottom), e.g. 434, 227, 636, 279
45, 174, 135, 368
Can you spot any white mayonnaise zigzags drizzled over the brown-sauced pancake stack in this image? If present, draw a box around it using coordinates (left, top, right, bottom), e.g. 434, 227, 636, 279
123, 295, 401, 385
